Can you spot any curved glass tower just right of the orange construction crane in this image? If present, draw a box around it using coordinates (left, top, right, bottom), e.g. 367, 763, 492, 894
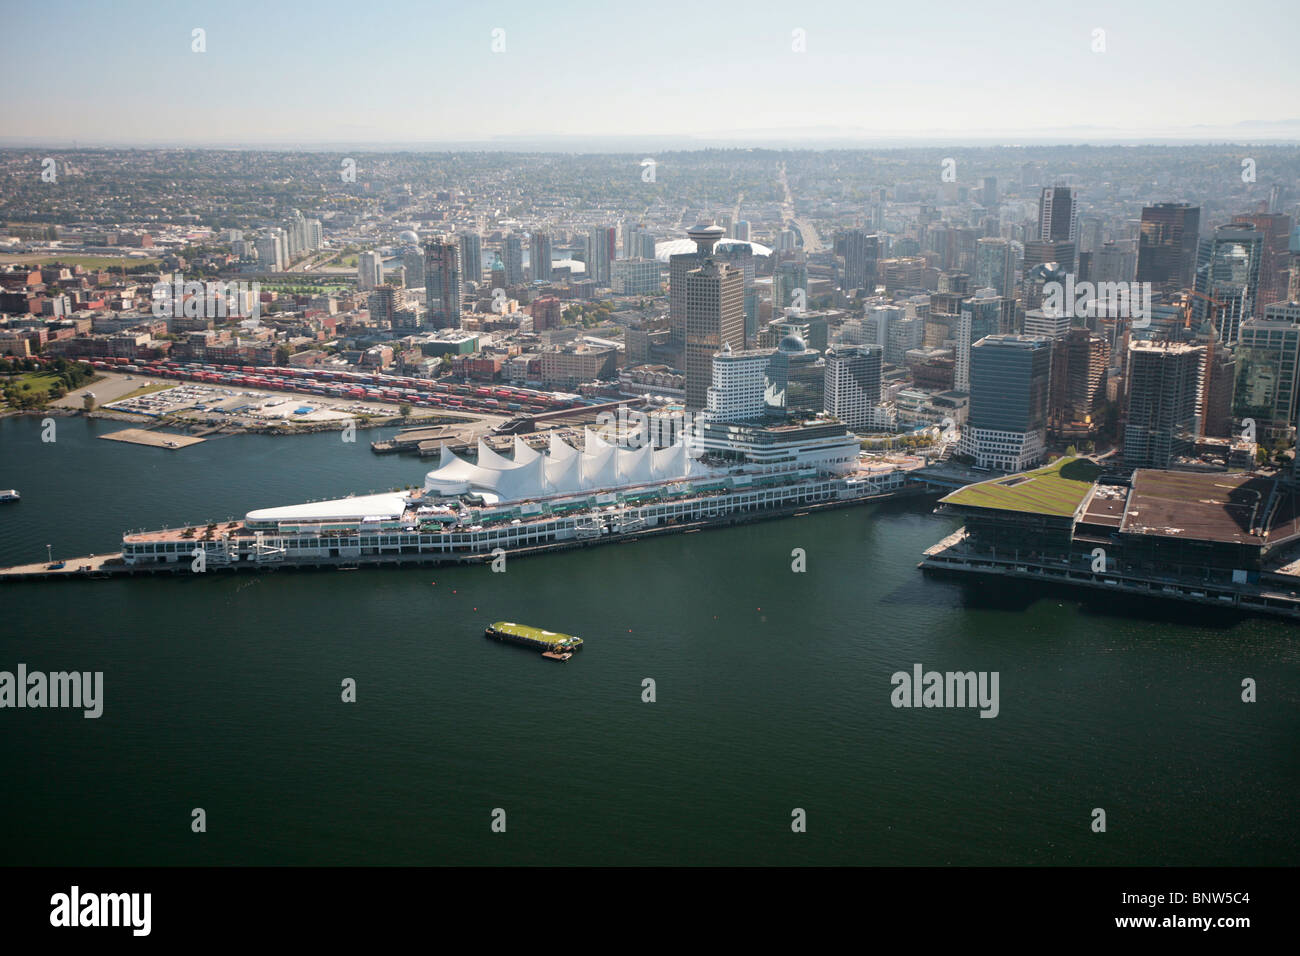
1192, 224, 1264, 345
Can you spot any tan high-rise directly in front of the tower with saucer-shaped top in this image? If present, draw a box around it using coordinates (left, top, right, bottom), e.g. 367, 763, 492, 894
684, 257, 745, 411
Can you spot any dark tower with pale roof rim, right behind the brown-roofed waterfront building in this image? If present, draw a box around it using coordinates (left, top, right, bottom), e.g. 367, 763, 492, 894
1123, 342, 1205, 468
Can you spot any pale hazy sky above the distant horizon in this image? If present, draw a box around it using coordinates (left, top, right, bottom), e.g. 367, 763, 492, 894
0, 0, 1300, 148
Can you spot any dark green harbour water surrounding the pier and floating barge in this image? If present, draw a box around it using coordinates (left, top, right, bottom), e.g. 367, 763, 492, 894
0, 419, 1300, 865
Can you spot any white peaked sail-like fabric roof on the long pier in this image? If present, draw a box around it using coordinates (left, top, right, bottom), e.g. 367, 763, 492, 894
424, 428, 722, 502
